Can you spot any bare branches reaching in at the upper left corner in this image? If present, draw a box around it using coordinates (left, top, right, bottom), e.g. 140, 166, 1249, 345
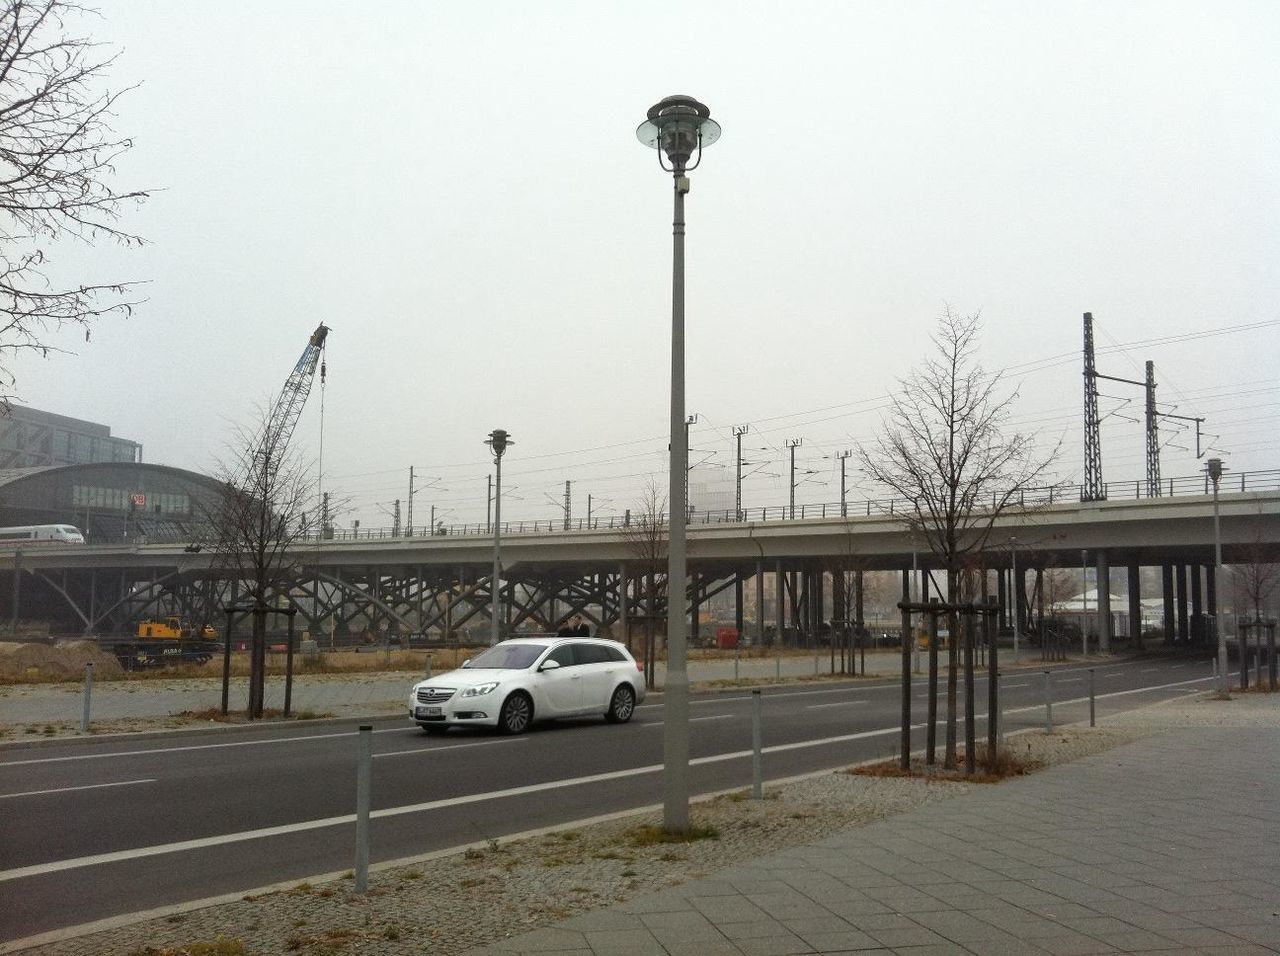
0, 0, 147, 404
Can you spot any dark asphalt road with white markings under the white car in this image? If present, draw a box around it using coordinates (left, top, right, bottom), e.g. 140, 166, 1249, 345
0, 658, 1211, 941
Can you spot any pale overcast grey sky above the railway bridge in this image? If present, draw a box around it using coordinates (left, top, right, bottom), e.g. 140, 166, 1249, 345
17, 0, 1280, 527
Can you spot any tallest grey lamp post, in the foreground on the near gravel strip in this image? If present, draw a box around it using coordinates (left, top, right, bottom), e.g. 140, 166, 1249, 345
636, 96, 721, 833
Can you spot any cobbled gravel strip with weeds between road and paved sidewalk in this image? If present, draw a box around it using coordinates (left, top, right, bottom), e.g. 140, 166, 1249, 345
0, 695, 1280, 956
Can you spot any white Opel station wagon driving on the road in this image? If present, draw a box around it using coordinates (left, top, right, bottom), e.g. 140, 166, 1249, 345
408, 637, 644, 733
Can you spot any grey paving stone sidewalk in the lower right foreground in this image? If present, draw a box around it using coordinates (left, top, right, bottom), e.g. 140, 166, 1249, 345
466, 727, 1280, 956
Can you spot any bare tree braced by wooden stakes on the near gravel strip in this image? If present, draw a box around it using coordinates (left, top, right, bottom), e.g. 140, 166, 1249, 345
858, 307, 1057, 769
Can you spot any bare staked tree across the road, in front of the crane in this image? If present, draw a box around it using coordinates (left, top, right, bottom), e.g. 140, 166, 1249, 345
206, 411, 317, 719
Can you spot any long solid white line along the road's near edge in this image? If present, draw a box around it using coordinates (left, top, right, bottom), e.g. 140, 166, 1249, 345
0, 677, 1213, 883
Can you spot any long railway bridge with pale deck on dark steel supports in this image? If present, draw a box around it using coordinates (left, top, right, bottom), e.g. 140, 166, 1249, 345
0, 471, 1280, 644
